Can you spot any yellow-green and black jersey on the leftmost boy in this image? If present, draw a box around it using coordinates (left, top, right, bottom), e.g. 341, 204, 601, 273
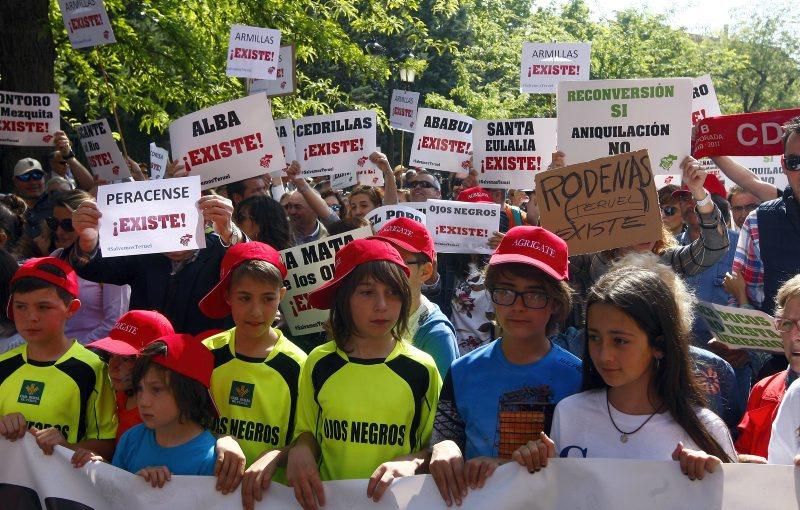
0, 341, 117, 443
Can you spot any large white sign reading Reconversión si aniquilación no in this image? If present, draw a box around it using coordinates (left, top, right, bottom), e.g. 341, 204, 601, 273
557, 78, 692, 174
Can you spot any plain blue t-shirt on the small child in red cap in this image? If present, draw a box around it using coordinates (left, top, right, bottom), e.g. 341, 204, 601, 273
111, 423, 217, 475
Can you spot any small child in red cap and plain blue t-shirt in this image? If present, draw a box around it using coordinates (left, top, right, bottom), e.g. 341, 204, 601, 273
112, 334, 216, 487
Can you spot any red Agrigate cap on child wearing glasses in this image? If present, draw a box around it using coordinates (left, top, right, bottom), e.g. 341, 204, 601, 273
489, 226, 569, 280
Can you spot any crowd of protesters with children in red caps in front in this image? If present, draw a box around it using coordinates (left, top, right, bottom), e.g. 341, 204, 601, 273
0, 118, 800, 509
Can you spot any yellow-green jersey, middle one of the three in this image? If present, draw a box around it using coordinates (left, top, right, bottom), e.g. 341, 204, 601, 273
203, 328, 306, 466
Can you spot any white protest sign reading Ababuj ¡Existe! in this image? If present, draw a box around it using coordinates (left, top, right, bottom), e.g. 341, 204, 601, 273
409, 108, 475, 172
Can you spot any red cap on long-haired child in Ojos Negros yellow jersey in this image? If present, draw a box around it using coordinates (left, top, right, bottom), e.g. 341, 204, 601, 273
308, 238, 411, 310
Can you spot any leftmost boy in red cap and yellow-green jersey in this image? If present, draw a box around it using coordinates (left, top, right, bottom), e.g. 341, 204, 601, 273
0, 257, 117, 456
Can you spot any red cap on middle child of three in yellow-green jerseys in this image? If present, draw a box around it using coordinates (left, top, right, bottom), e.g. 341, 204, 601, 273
198, 241, 286, 319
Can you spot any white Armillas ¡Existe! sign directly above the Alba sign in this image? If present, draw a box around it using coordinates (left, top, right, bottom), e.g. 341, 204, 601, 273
225, 25, 281, 80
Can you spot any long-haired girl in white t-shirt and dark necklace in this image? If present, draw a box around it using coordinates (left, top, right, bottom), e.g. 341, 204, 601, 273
513, 255, 737, 480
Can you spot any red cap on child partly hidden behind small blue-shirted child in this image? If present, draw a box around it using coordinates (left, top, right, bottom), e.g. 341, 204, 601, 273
86, 310, 175, 356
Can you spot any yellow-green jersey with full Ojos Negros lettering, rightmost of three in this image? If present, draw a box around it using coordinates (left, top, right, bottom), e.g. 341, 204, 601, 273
295, 342, 442, 480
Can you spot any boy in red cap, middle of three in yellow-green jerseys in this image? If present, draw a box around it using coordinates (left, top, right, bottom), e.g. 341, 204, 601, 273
200, 241, 306, 508
